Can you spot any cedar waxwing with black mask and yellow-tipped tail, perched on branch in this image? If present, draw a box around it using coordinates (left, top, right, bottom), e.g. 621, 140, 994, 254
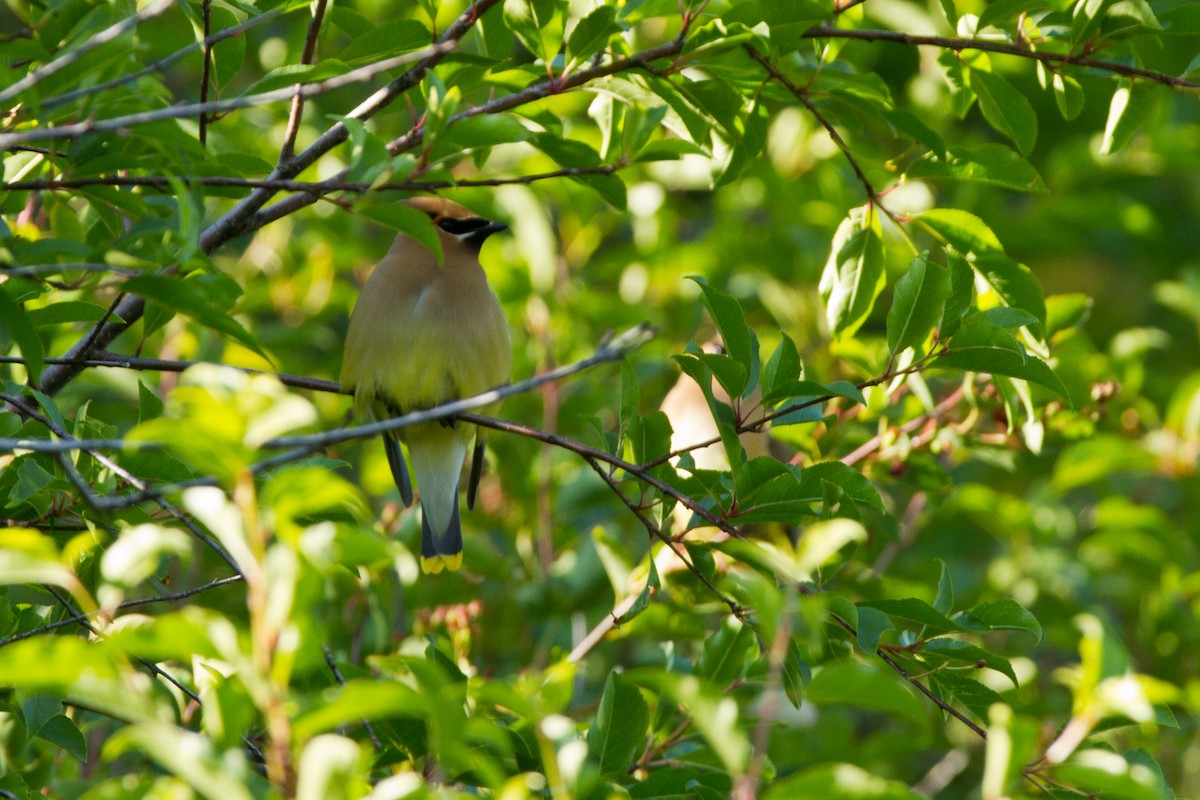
341, 197, 512, 572
